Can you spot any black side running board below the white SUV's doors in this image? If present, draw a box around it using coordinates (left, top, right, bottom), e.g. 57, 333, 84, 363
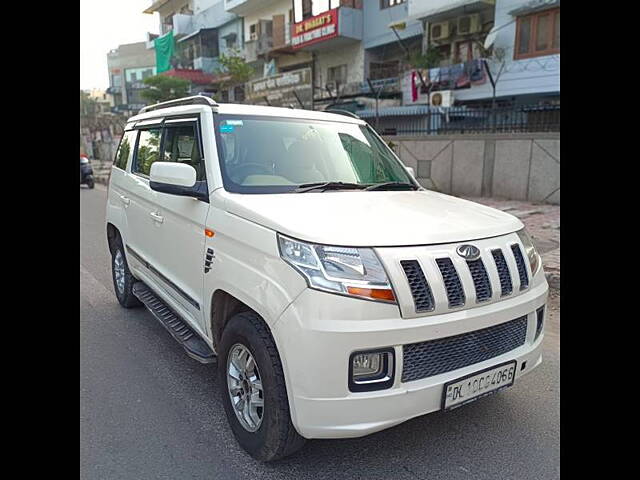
133, 282, 216, 363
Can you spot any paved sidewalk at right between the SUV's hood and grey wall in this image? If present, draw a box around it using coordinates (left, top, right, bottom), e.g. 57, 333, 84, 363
462, 197, 560, 290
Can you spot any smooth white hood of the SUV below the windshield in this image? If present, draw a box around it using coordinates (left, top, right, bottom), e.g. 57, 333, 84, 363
216, 189, 524, 247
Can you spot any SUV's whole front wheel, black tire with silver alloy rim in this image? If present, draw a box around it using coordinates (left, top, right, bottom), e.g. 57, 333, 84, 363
218, 312, 305, 461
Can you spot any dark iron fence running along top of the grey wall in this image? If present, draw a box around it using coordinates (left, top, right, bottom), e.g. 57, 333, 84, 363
365, 105, 560, 135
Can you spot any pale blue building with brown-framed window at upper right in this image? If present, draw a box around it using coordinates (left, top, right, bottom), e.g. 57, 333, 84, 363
408, 0, 560, 105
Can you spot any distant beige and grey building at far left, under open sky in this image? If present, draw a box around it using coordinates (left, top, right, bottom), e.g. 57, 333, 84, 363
106, 42, 156, 114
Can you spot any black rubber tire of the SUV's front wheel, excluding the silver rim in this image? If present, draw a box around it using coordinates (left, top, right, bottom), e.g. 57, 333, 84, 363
218, 312, 306, 462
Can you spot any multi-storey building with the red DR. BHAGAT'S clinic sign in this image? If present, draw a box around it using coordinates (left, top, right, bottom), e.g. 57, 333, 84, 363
232, 0, 422, 111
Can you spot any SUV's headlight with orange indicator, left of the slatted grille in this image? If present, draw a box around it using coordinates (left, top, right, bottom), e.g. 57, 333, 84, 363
278, 235, 396, 303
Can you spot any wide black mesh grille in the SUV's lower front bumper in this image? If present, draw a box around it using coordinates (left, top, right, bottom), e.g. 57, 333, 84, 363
402, 316, 527, 382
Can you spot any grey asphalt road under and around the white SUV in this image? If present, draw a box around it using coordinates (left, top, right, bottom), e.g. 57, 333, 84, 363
80, 185, 560, 480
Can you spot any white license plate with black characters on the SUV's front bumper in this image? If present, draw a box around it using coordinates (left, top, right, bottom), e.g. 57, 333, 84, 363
442, 360, 516, 410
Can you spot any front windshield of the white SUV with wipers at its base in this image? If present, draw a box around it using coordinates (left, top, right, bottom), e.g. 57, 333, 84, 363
215, 115, 417, 193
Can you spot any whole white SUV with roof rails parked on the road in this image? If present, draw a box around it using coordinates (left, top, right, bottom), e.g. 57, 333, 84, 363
107, 96, 548, 460
